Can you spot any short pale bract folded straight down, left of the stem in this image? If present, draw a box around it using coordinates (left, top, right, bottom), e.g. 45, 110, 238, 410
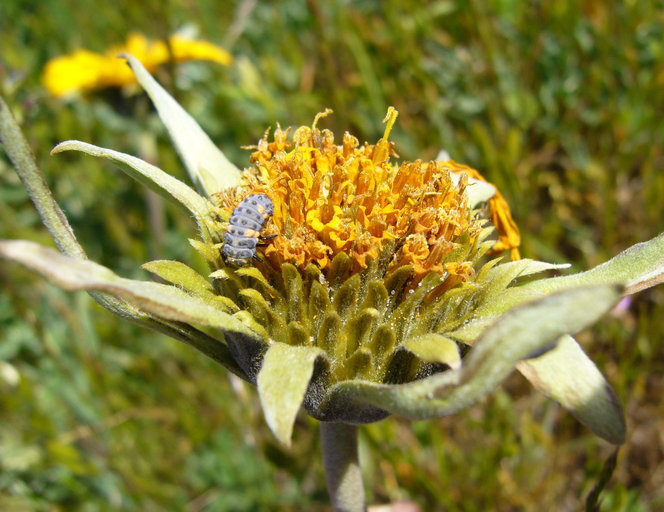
257, 343, 324, 446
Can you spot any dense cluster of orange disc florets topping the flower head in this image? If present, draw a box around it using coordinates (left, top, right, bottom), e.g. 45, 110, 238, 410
215, 110, 490, 277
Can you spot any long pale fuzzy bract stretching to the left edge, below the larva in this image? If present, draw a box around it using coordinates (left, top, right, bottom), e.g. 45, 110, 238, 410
0, 240, 257, 338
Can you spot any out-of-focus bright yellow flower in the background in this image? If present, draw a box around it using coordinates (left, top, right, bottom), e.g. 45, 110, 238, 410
42, 33, 233, 97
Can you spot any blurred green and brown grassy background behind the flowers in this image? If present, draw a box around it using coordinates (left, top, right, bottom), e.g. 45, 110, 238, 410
0, 0, 664, 512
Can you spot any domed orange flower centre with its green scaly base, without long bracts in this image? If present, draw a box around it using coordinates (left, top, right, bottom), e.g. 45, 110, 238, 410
205, 109, 518, 398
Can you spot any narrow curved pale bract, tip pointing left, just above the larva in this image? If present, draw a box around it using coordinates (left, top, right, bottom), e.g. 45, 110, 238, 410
51, 140, 210, 225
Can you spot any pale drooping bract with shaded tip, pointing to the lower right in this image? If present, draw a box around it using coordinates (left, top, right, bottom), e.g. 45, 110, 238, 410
517, 336, 625, 444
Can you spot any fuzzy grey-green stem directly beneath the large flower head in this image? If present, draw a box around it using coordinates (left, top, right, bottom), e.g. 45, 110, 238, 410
320, 422, 367, 512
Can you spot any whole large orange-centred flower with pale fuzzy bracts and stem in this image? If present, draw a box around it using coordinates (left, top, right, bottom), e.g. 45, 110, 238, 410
0, 56, 664, 510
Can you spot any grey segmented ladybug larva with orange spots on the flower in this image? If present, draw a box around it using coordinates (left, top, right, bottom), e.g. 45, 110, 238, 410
221, 194, 276, 267
